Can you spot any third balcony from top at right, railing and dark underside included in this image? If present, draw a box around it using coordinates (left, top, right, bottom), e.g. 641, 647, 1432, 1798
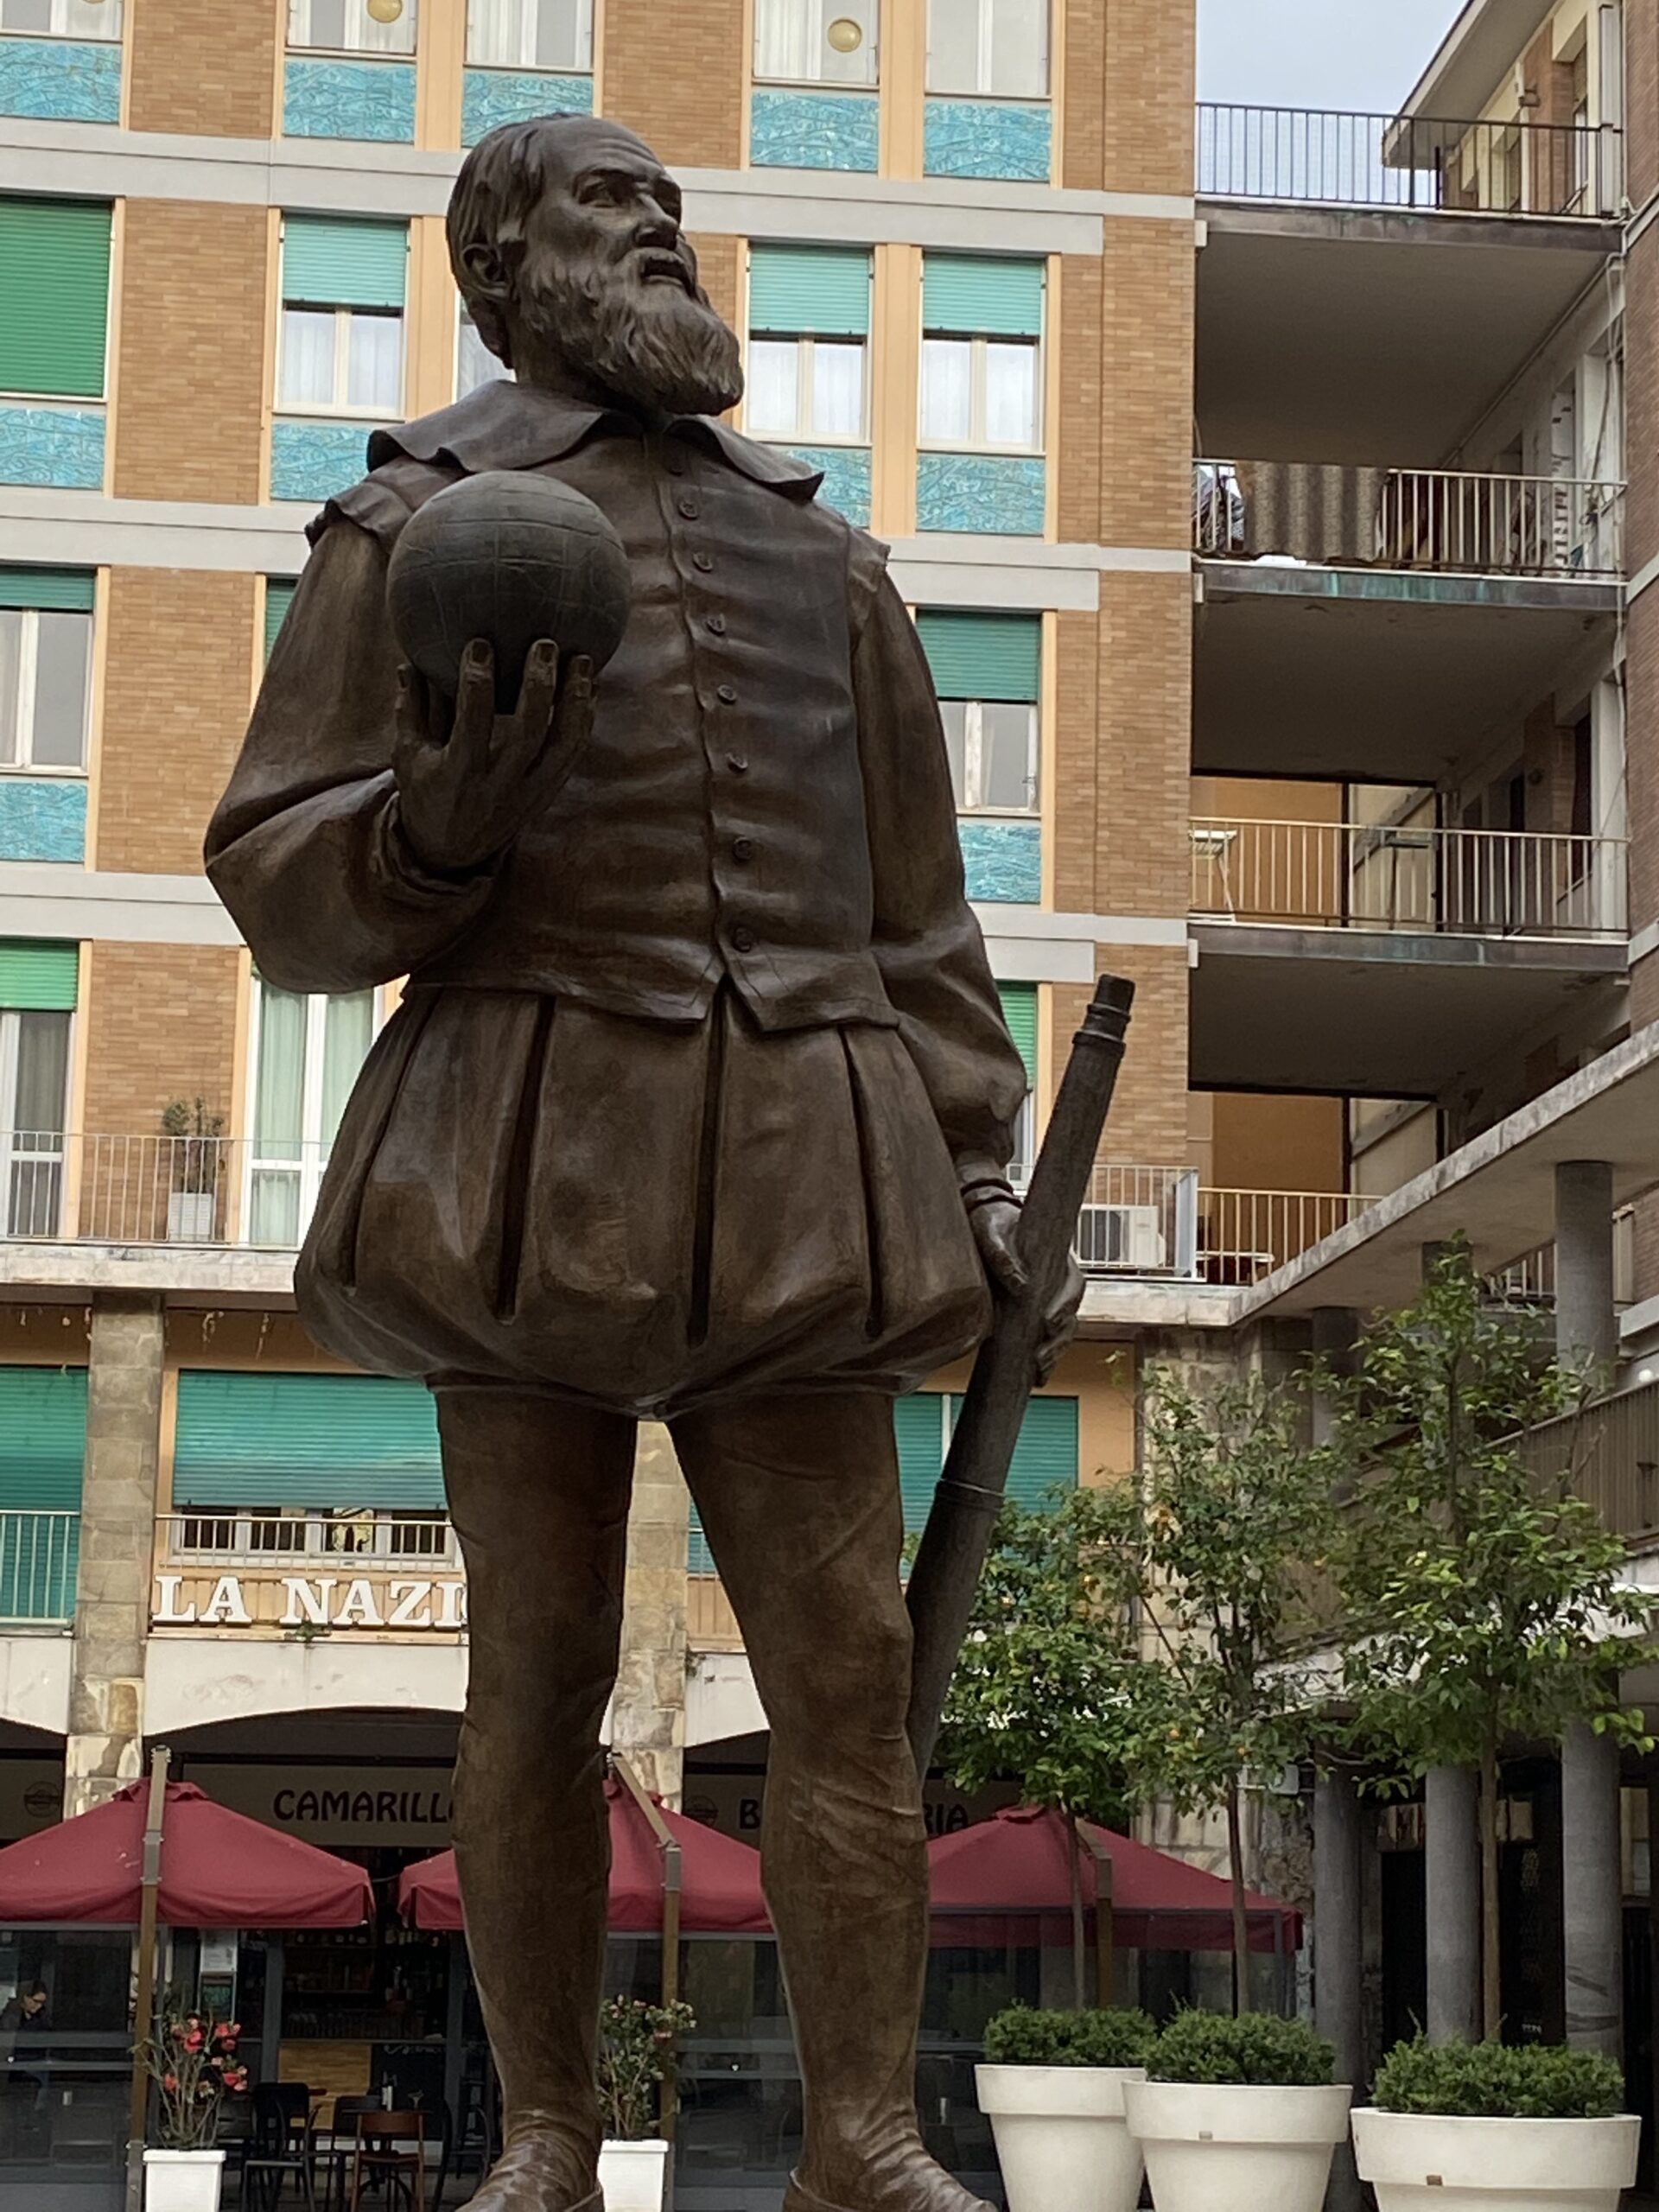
1192, 821, 1626, 1097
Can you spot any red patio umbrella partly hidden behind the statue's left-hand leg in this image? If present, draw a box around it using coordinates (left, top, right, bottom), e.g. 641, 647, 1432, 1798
398, 1781, 772, 1936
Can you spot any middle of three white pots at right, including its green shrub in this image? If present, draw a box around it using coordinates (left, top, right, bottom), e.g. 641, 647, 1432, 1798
1123, 2013, 1354, 2212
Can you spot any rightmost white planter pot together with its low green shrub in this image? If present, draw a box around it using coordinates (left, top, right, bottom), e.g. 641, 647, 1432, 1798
1354, 2035, 1642, 2212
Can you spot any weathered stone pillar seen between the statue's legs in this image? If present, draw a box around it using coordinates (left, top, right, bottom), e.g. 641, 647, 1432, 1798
611, 1422, 690, 1808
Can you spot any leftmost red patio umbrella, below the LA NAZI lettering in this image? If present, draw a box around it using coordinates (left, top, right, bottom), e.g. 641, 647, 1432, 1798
0, 1783, 374, 1929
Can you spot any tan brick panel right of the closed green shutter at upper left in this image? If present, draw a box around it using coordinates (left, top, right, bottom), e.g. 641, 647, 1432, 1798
115, 199, 270, 502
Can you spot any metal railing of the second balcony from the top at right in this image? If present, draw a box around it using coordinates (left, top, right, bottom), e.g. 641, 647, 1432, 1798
1192, 460, 1624, 577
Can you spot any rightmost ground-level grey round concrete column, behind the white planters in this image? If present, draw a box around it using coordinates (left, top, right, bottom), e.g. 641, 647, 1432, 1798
1561, 1721, 1624, 2059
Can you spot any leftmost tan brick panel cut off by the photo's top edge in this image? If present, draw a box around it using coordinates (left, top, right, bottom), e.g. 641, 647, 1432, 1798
126, 0, 288, 137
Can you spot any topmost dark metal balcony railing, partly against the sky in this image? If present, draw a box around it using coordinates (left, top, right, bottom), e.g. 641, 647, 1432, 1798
1197, 99, 1624, 217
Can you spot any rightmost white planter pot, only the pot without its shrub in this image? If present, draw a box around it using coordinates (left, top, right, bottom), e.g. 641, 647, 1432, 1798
1354, 2106, 1642, 2212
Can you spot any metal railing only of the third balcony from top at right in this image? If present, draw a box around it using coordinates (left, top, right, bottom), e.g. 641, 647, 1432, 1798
1192, 821, 1626, 938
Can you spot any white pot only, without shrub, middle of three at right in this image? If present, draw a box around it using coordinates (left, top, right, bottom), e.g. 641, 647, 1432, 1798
1123, 2082, 1353, 2212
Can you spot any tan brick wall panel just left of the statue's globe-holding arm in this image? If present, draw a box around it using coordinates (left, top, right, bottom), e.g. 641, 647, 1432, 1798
98, 569, 257, 876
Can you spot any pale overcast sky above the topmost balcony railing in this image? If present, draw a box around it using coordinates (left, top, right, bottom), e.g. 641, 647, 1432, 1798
1199, 0, 1462, 113
